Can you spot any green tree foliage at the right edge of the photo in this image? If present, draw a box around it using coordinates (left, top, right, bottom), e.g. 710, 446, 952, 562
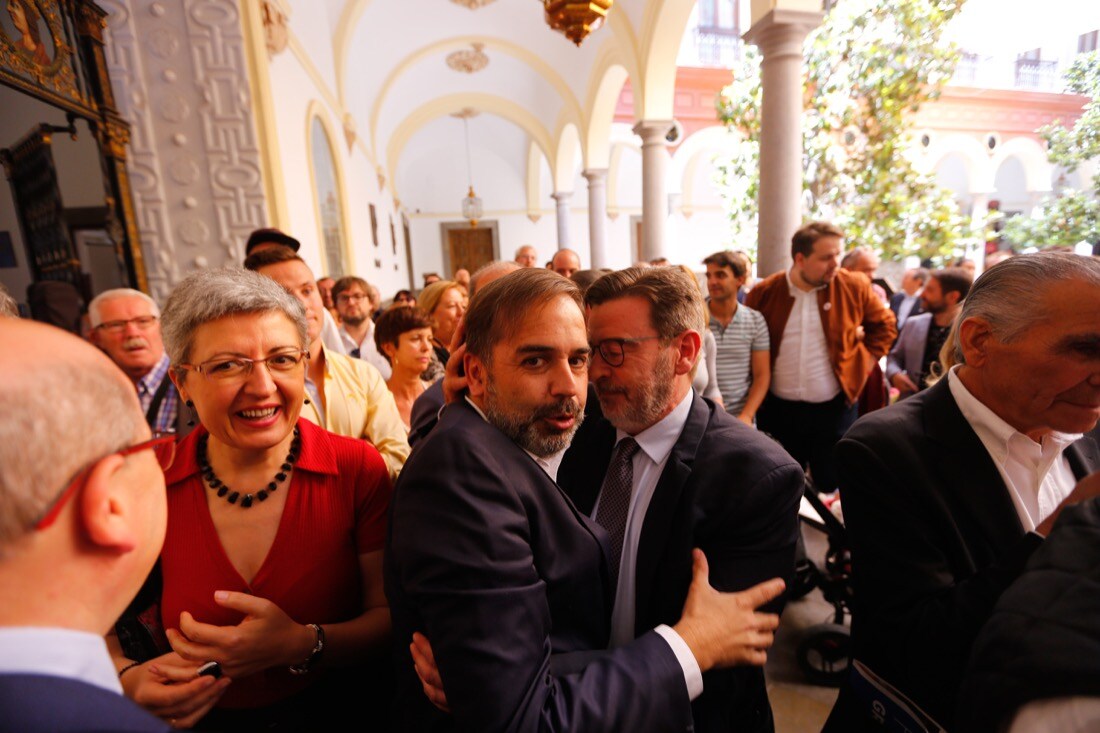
1001, 51, 1100, 249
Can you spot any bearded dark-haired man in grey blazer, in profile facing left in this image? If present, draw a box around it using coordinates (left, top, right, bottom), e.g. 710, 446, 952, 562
887, 267, 974, 397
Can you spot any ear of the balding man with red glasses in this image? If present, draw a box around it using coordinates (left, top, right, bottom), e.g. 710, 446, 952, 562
76, 455, 138, 554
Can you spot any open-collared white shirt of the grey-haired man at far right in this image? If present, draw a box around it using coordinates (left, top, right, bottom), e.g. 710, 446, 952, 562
947, 365, 1081, 532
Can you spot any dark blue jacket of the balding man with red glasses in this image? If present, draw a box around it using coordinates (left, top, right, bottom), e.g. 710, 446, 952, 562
0, 675, 172, 733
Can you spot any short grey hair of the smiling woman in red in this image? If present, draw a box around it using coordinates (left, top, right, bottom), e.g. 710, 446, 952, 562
161, 267, 309, 367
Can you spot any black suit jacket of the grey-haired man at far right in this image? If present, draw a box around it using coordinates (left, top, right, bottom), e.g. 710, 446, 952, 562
825, 379, 1100, 733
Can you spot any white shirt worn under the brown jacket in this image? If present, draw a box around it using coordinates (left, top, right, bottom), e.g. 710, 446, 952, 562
770, 270, 840, 403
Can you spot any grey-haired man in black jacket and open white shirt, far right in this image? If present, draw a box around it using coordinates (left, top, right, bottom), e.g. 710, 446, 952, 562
826, 253, 1100, 732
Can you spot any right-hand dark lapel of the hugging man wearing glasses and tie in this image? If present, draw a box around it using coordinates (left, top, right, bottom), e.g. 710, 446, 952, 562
634, 394, 711, 634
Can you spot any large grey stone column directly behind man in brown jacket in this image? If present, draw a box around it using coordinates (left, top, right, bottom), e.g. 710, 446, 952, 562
745, 8, 824, 277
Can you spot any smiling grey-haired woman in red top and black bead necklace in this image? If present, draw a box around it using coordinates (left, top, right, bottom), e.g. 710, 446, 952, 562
110, 270, 389, 731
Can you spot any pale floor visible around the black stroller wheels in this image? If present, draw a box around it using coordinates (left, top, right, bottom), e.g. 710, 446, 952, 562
765, 527, 836, 733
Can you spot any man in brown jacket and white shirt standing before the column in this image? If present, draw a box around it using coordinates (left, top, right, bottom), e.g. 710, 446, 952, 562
745, 221, 898, 492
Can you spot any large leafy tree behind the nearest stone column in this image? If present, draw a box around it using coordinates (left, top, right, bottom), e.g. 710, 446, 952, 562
717, 0, 971, 259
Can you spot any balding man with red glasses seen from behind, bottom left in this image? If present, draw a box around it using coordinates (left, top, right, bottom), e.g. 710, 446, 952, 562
0, 319, 188, 733
